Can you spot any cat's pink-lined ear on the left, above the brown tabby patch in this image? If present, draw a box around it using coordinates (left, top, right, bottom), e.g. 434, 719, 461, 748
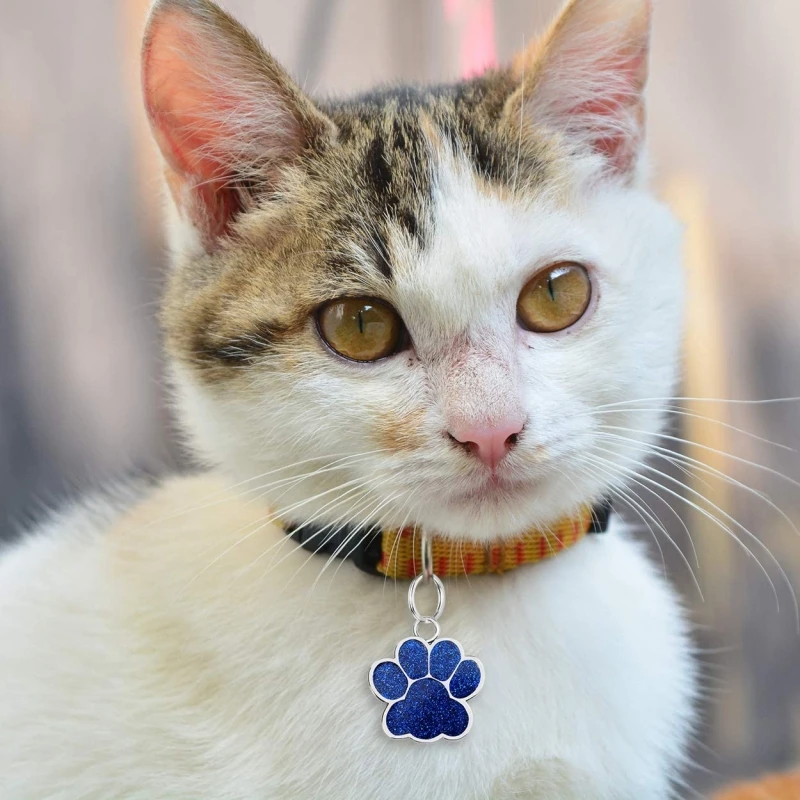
142, 0, 335, 250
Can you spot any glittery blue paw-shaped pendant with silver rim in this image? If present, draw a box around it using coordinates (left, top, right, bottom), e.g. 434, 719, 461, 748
369, 638, 483, 742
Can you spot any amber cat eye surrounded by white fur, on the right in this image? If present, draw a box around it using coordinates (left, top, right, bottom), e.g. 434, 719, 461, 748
517, 263, 592, 333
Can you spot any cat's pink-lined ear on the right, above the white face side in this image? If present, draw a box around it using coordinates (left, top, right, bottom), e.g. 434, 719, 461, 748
506, 0, 652, 179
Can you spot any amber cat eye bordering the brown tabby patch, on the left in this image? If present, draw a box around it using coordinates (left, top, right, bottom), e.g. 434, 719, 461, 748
317, 297, 405, 361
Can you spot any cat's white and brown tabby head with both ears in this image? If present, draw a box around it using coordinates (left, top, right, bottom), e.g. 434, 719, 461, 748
143, 0, 681, 539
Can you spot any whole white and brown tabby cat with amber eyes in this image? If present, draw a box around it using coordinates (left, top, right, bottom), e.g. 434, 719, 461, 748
0, 0, 697, 800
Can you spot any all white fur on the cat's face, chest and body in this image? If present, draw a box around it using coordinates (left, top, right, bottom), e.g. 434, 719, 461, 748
0, 0, 695, 800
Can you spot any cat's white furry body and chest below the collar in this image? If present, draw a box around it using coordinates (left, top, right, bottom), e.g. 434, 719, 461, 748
0, 477, 693, 800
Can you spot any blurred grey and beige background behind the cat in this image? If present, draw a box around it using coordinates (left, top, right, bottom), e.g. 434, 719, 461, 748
0, 0, 800, 797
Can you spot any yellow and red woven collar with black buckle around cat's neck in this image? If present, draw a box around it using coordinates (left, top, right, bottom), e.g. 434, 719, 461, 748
284, 501, 611, 580
